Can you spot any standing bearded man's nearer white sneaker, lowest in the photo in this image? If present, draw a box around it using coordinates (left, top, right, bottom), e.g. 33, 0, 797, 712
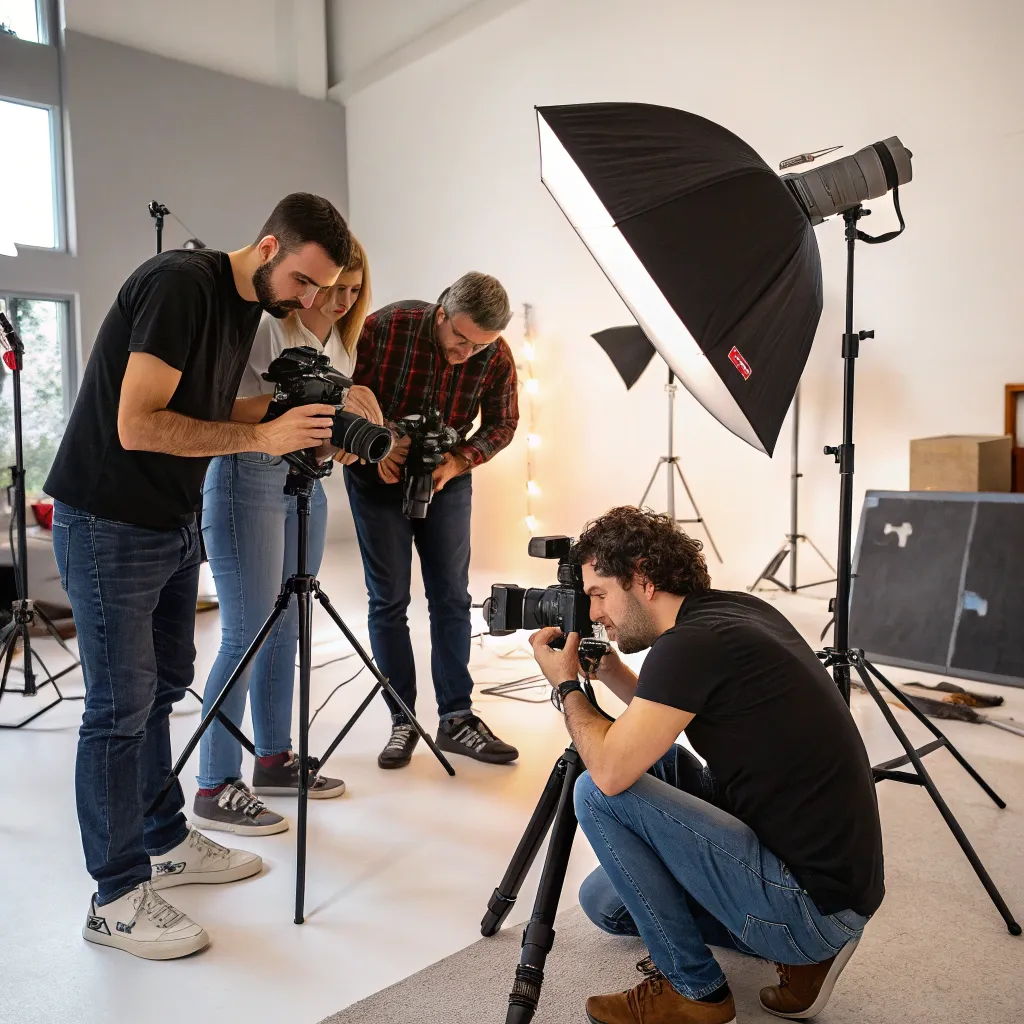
82, 882, 210, 959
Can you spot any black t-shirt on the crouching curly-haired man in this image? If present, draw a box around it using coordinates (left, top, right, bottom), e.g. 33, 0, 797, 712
637, 591, 885, 915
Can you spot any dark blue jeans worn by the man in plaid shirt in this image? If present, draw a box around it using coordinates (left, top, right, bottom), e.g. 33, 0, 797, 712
345, 470, 473, 717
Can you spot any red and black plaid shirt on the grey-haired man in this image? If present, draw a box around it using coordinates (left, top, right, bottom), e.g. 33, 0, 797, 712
352, 302, 519, 466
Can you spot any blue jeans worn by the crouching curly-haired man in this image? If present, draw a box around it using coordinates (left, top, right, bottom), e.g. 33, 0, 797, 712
575, 746, 867, 999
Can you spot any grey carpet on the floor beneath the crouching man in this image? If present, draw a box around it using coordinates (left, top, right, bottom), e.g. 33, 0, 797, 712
323, 745, 1024, 1024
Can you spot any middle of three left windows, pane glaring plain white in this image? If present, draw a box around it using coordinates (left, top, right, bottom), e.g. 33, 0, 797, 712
0, 98, 60, 249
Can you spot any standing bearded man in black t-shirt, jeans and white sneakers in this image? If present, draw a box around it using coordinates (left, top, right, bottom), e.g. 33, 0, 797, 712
45, 193, 350, 959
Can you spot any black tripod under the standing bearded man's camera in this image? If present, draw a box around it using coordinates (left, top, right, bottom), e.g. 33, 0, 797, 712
146, 464, 455, 925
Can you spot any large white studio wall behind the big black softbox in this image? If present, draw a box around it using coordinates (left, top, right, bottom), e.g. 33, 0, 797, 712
347, 0, 1024, 586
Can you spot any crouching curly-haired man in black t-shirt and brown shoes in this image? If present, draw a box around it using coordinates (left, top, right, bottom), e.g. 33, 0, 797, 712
531, 507, 884, 1024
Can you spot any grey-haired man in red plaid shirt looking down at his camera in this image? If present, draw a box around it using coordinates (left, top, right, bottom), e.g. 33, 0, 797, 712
345, 272, 519, 768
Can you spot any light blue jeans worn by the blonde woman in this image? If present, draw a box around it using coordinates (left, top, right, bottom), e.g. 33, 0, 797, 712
198, 452, 327, 790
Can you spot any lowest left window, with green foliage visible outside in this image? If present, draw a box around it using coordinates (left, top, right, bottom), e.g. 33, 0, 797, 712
0, 295, 73, 494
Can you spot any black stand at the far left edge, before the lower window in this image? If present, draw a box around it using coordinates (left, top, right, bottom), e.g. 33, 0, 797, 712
0, 313, 83, 729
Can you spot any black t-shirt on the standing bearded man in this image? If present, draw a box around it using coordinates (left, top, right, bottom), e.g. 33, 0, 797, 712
44, 249, 261, 529
